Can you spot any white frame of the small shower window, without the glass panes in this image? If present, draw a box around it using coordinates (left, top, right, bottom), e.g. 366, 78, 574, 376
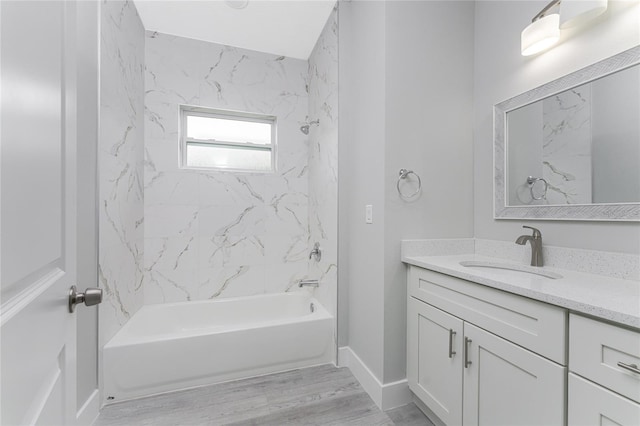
178, 105, 278, 174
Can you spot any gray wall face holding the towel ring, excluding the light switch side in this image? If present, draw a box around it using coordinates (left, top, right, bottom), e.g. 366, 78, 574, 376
383, 1, 474, 383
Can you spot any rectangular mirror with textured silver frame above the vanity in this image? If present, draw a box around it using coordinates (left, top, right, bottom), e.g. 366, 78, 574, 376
494, 46, 640, 221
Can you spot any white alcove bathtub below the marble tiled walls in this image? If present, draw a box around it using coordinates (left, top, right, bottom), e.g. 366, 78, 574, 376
102, 291, 334, 403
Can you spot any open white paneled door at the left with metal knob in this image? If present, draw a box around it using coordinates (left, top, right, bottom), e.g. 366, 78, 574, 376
0, 1, 85, 425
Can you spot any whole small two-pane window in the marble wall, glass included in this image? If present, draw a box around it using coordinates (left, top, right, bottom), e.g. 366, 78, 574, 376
180, 106, 276, 172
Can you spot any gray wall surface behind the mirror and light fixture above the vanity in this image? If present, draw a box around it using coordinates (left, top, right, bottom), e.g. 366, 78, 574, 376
474, 1, 640, 253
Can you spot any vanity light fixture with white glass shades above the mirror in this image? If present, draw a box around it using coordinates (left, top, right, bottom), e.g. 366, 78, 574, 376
520, 0, 607, 56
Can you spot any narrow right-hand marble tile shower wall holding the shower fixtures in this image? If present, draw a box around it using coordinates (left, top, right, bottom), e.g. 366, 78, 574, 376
309, 7, 338, 315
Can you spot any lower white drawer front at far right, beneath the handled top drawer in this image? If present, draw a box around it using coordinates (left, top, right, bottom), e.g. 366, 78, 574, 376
569, 373, 640, 426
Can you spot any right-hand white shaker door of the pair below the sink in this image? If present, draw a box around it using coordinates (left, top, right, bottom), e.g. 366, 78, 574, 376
463, 323, 566, 426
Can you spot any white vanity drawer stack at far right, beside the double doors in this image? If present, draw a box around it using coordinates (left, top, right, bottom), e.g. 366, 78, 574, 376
568, 314, 640, 426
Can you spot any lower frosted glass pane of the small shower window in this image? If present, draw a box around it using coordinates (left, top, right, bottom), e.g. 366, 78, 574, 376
187, 143, 271, 171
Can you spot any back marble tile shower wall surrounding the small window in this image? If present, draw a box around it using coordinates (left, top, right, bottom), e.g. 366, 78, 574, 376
144, 32, 309, 304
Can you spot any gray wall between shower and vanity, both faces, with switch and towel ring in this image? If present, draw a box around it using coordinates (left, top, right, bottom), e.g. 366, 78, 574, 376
339, 1, 473, 383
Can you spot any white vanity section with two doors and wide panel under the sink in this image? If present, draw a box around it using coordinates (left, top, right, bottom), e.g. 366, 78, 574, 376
407, 267, 567, 425
